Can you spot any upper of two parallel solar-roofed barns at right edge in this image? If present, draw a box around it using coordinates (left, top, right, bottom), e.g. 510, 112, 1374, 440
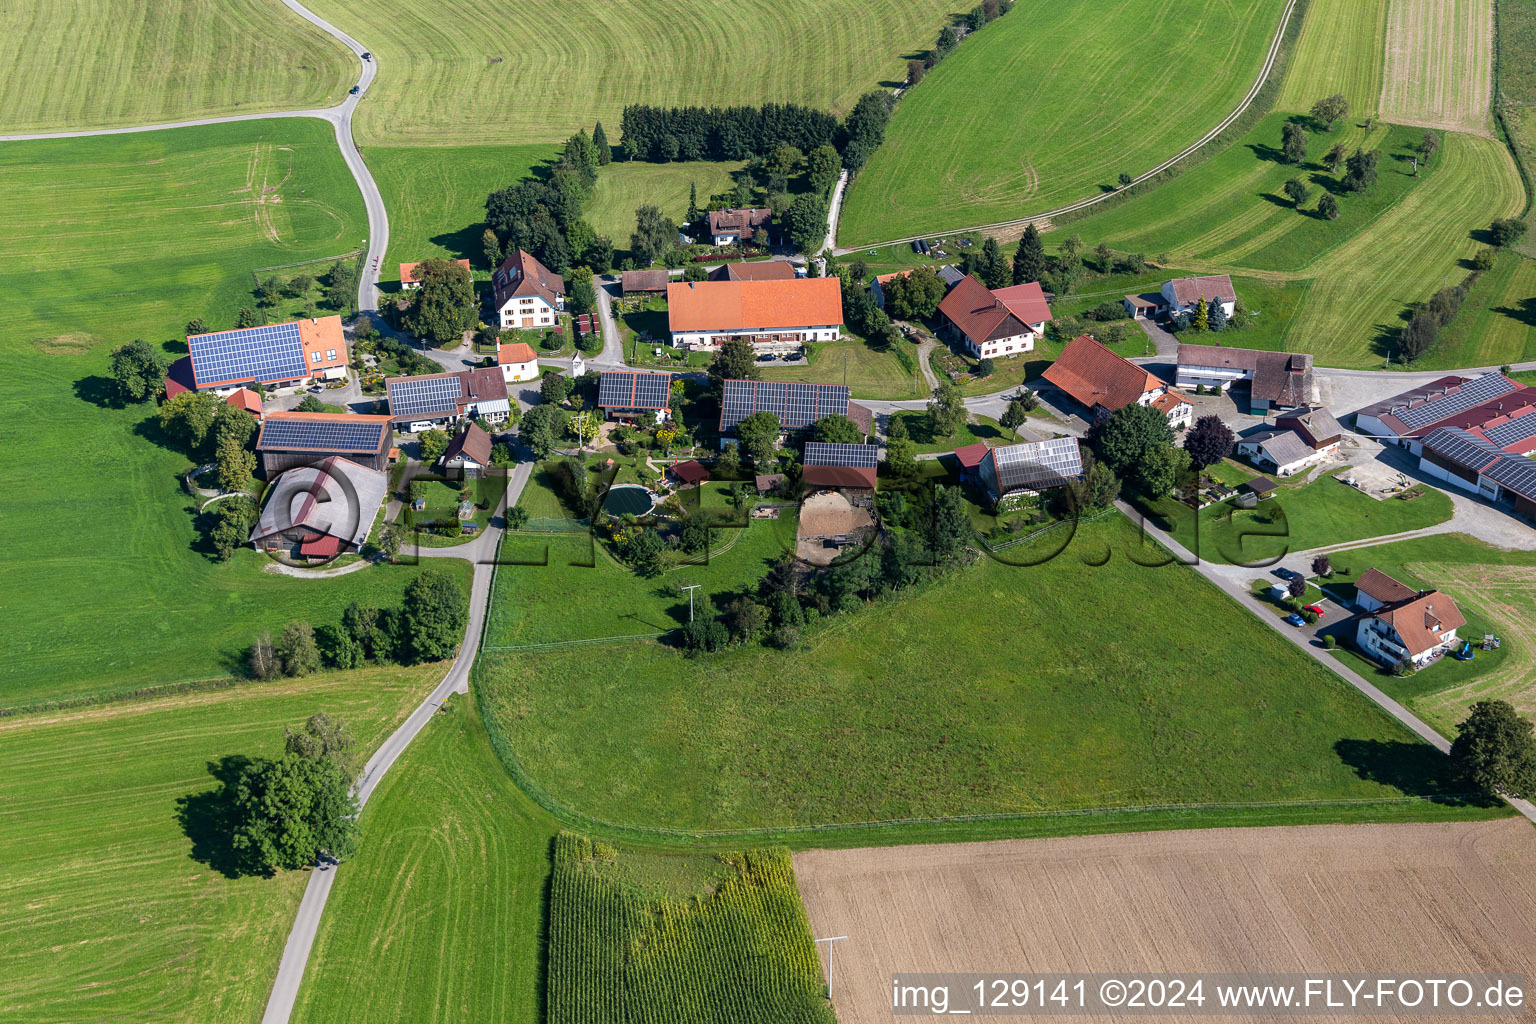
1355, 373, 1536, 454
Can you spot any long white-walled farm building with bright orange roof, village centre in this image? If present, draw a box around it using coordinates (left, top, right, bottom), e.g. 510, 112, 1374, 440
667, 278, 843, 352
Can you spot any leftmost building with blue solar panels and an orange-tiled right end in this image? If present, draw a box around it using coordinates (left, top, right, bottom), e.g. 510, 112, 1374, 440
182, 316, 347, 395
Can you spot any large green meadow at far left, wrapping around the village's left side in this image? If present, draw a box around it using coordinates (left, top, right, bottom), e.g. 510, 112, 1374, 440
0, 120, 473, 705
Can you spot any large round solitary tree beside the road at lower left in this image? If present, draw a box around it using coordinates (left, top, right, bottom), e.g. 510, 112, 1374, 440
230, 752, 358, 874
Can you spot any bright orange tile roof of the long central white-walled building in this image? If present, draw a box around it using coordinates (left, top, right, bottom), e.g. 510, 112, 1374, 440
667, 278, 843, 332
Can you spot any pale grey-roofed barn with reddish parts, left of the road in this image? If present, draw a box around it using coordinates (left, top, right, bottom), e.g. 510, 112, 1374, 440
250, 456, 389, 560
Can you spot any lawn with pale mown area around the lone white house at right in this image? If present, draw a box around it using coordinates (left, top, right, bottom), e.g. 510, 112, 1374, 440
1319, 534, 1536, 735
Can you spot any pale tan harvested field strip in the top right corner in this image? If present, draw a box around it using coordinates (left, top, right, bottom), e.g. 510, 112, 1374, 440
1382, 0, 1493, 135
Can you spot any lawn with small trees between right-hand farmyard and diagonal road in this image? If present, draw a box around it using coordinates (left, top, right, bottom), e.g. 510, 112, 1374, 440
1136, 470, 1453, 565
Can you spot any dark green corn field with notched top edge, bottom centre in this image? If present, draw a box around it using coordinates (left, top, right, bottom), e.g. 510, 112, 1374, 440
548, 834, 836, 1024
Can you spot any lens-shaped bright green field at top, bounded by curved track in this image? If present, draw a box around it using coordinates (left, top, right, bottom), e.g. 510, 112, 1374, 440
837, 0, 1284, 246
